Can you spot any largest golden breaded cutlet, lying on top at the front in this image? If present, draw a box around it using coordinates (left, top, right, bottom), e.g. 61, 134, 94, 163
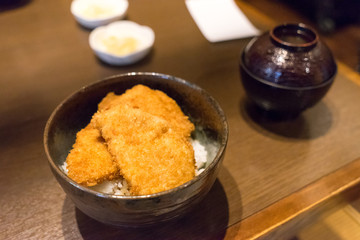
92, 105, 195, 195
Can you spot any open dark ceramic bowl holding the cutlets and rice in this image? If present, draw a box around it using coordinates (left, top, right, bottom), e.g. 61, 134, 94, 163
44, 73, 228, 226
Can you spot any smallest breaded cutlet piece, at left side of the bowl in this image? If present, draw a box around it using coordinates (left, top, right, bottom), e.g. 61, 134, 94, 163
66, 124, 119, 186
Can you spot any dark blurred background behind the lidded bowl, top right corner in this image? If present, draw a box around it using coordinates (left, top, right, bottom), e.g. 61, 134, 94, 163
244, 0, 360, 72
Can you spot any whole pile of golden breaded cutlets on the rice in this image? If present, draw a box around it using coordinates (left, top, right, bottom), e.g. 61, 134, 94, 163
66, 85, 195, 195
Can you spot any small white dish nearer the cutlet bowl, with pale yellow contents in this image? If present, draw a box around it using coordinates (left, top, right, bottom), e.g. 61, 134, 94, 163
89, 20, 155, 66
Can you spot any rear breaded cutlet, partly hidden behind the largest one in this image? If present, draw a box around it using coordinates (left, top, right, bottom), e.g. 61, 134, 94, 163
99, 84, 195, 137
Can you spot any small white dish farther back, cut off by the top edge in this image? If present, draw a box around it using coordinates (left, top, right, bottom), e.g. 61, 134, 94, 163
70, 0, 129, 29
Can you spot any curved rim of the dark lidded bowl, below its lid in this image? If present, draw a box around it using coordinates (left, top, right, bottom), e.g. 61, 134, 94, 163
240, 49, 338, 91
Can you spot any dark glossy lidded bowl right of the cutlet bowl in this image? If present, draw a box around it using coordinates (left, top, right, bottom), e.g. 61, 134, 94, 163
240, 24, 337, 115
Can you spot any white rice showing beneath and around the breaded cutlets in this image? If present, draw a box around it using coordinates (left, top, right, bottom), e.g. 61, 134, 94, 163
60, 139, 215, 196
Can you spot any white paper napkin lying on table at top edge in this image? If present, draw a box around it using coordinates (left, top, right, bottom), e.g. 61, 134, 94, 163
185, 0, 260, 42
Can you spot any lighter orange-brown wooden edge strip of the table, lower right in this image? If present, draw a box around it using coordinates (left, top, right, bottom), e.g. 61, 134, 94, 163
226, 158, 360, 239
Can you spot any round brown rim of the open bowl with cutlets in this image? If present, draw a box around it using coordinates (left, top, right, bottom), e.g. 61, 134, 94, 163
43, 72, 229, 200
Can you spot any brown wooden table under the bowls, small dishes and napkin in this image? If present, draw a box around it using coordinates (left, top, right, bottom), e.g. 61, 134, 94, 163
0, 0, 360, 239
